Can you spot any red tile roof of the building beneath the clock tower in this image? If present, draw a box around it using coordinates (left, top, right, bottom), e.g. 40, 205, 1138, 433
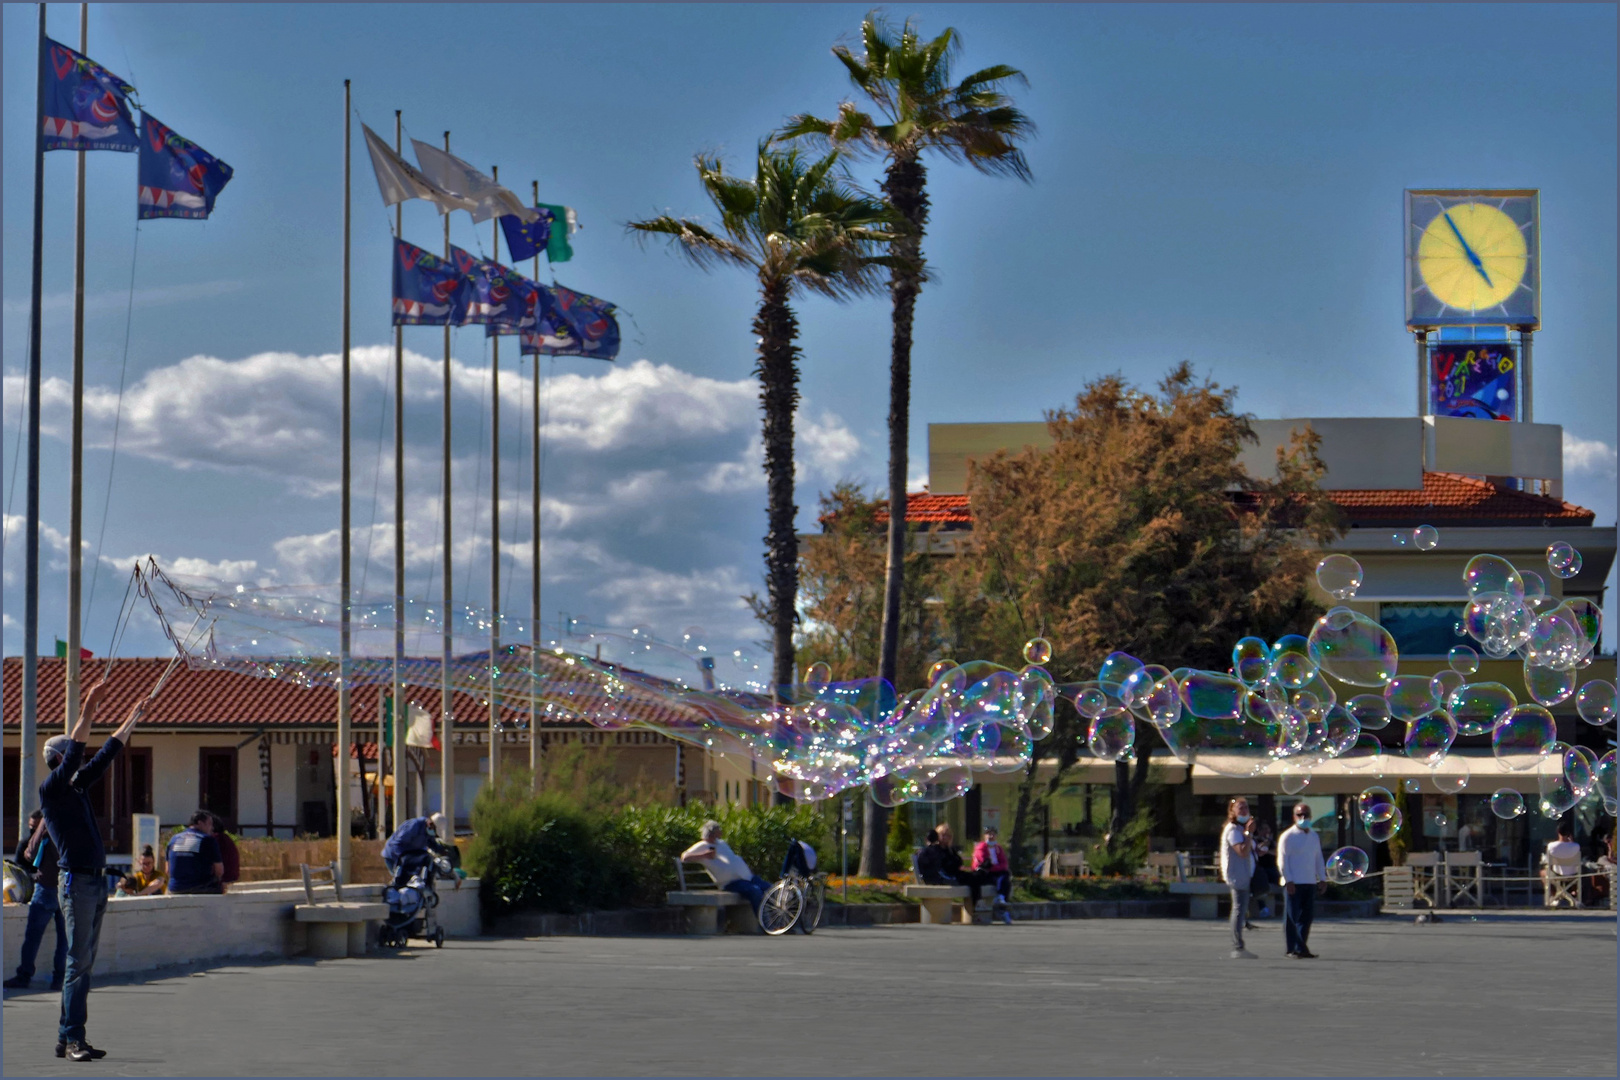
876, 473, 1597, 526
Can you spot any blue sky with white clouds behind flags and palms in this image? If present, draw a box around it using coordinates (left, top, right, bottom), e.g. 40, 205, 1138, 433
0, 5, 1617, 667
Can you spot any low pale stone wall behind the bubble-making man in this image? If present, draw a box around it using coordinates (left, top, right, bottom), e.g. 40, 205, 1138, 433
5, 878, 480, 984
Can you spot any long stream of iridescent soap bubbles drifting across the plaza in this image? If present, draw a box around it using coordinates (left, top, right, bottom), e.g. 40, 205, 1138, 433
138, 526, 1617, 809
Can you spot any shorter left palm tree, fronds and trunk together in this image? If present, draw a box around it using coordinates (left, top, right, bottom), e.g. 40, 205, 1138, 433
627, 142, 896, 709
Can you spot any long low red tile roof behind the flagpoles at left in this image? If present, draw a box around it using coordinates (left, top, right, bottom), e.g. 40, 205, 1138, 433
3, 656, 523, 732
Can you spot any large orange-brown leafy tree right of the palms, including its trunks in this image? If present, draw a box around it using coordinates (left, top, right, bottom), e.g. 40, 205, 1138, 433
943, 364, 1338, 874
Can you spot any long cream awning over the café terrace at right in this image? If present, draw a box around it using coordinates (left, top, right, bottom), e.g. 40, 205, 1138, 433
1192, 750, 1541, 795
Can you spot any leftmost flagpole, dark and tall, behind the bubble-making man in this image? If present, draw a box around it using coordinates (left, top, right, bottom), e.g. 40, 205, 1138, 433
16, 3, 45, 837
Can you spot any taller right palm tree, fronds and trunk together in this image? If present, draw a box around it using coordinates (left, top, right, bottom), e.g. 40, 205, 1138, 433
776, 13, 1035, 876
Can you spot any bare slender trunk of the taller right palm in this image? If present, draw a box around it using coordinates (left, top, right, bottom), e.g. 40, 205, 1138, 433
860, 155, 928, 878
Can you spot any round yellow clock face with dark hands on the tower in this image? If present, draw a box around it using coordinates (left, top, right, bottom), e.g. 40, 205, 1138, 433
1416, 202, 1529, 311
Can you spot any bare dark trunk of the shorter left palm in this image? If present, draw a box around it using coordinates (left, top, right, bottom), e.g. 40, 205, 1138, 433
753, 282, 799, 702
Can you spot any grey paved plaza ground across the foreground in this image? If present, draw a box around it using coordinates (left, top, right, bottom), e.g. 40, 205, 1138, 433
5, 916, 1617, 1077
